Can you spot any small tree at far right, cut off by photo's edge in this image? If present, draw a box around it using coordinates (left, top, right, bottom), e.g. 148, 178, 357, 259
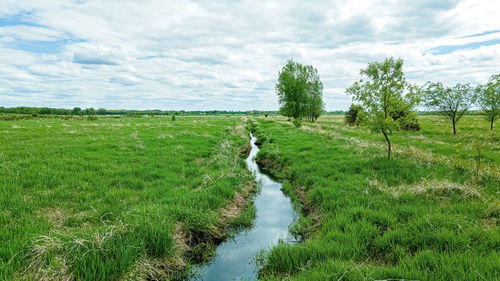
476, 74, 500, 130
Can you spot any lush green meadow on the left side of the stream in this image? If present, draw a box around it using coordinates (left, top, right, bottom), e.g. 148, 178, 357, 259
0, 116, 253, 280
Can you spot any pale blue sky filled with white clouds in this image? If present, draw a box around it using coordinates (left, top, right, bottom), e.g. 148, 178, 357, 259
0, 0, 500, 111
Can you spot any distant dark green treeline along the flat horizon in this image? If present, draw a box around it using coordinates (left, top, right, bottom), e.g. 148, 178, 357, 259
0, 106, 481, 116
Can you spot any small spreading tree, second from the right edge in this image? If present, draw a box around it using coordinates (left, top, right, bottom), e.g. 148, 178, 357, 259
424, 82, 476, 135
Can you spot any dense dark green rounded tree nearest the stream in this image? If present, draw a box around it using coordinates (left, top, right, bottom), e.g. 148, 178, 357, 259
275, 60, 323, 121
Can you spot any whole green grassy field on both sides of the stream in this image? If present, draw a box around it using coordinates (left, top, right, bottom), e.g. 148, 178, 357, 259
0, 116, 500, 280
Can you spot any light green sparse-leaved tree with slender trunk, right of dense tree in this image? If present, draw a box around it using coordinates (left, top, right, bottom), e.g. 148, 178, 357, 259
347, 58, 420, 159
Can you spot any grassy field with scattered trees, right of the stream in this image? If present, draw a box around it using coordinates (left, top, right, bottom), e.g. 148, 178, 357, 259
258, 117, 500, 280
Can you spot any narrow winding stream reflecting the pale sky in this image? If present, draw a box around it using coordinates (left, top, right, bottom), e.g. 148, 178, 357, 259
192, 133, 296, 281
